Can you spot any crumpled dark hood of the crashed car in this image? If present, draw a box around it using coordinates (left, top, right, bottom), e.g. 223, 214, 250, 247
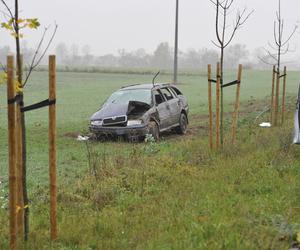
90, 101, 151, 121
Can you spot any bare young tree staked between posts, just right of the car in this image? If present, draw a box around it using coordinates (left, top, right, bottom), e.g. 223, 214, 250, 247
210, 0, 254, 145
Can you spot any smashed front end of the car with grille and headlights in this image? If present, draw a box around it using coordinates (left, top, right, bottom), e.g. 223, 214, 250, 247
90, 101, 151, 140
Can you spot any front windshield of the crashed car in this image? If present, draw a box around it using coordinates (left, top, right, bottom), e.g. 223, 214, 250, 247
106, 89, 152, 105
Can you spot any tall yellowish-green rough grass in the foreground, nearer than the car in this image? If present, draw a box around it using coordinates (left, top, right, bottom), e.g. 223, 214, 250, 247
0, 103, 300, 249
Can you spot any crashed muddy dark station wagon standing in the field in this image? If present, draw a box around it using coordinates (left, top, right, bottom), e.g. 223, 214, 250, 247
89, 84, 189, 140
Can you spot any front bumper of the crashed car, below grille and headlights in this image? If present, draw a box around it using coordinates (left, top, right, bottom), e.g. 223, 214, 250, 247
89, 125, 149, 137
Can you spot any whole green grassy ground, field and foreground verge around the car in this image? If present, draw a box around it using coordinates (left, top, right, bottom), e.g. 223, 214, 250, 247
0, 71, 300, 249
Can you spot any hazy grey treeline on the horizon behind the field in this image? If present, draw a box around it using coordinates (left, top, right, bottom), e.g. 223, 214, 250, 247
0, 42, 298, 70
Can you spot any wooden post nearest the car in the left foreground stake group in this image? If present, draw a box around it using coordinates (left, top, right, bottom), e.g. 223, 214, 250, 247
49, 56, 57, 240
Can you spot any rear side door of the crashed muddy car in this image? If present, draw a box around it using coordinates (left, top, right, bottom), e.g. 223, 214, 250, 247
160, 87, 181, 126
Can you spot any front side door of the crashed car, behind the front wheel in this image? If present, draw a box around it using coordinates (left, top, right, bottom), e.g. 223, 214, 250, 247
153, 90, 171, 130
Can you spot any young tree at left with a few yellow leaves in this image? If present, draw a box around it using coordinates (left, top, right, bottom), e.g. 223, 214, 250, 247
0, 0, 58, 240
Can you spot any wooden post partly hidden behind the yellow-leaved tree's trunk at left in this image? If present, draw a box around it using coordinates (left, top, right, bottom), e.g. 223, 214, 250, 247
16, 55, 24, 237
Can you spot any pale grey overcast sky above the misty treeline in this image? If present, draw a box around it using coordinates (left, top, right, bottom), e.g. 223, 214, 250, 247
0, 0, 300, 55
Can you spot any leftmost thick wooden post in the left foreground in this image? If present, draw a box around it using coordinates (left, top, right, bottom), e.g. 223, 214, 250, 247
7, 56, 17, 250
